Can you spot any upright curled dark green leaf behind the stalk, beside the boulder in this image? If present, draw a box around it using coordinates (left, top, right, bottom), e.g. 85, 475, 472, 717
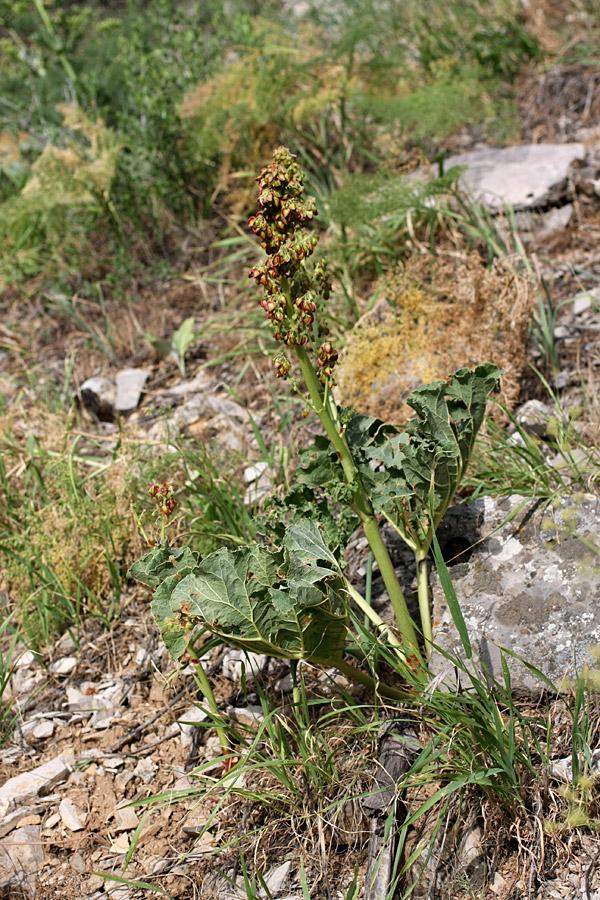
298, 363, 500, 549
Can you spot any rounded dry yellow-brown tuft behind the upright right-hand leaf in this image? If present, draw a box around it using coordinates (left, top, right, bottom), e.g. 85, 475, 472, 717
338, 252, 535, 424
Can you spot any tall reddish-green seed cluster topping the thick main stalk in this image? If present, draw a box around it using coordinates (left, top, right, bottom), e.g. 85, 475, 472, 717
248, 147, 337, 384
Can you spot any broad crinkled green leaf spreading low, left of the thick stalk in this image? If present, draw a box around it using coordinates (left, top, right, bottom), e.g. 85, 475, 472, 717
145, 520, 348, 664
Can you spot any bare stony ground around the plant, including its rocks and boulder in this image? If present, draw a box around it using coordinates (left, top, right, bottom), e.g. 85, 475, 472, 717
0, 68, 600, 900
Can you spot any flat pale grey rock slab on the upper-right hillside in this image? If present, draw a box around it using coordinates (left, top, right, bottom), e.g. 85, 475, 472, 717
444, 144, 586, 209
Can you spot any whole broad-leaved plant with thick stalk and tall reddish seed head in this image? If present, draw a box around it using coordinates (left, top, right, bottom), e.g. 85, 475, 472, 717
131, 147, 500, 696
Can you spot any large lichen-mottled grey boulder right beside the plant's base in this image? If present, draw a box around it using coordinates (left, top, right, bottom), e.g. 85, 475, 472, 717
431, 494, 600, 693
